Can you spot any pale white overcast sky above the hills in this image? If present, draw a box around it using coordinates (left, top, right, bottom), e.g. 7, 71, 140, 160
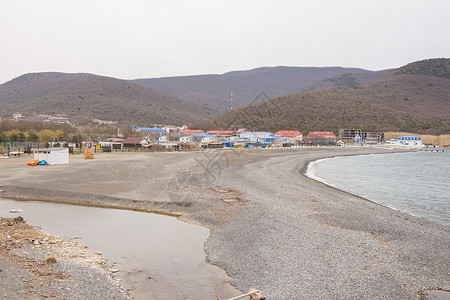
0, 0, 450, 83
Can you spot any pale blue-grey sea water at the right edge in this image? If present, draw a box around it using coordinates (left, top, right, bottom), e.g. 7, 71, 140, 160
307, 151, 450, 226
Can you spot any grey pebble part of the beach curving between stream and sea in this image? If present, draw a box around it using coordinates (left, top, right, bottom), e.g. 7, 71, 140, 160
201, 149, 450, 299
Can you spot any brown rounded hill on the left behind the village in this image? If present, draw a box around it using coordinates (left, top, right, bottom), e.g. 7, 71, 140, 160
0, 73, 213, 125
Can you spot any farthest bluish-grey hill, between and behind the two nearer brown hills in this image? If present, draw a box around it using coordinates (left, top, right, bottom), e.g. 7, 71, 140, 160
132, 67, 382, 112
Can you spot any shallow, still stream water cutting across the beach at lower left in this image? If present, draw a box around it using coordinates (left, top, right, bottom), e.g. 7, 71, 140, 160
0, 198, 239, 299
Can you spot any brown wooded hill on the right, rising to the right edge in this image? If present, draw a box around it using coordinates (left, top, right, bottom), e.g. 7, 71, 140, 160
197, 59, 450, 134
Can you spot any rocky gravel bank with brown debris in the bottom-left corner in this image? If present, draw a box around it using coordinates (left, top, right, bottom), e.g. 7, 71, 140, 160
0, 217, 130, 300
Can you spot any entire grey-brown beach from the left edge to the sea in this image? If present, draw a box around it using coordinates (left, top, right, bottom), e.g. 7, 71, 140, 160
0, 147, 450, 299
